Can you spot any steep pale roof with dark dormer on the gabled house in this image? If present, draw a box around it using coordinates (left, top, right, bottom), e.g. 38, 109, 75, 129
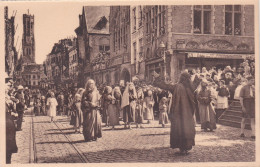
83, 6, 110, 34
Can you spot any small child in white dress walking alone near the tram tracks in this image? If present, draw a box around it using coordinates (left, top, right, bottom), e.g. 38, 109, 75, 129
46, 92, 58, 122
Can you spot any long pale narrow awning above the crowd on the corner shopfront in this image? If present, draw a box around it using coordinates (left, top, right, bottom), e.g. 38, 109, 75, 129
186, 52, 255, 59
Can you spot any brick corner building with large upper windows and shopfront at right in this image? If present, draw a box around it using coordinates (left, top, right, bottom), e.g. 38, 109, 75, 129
143, 5, 254, 82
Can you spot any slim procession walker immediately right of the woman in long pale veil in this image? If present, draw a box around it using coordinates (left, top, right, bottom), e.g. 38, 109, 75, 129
135, 87, 144, 128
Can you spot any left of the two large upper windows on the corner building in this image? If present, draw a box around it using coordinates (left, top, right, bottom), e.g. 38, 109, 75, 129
193, 5, 211, 34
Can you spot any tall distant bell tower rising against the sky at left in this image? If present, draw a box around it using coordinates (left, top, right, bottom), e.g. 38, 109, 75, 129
22, 10, 35, 64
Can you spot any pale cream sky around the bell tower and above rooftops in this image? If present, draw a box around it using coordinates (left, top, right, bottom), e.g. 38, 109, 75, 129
5, 2, 83, 64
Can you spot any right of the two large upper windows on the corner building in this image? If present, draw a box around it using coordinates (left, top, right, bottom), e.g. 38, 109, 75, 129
225, 5, 241, 35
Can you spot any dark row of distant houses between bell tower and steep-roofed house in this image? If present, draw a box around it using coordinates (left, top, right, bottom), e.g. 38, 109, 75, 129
44, 38, 75, 88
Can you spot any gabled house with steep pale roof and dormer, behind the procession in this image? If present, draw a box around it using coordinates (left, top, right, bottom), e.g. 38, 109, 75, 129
75, 6, 110, 87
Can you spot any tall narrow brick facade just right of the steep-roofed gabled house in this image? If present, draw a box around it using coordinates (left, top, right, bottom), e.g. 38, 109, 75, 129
109, 6, 134, 85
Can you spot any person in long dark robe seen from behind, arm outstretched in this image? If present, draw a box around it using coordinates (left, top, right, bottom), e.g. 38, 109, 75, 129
154, 72, 196, 155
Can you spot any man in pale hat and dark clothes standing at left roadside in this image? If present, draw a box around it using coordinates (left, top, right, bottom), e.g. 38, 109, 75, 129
15, 85, 25, 131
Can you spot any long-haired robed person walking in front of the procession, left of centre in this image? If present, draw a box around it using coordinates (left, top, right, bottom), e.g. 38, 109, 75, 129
81, 79, 102, 142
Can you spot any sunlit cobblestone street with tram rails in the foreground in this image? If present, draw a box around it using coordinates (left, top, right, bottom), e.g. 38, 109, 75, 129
12, 113, 255, 163
